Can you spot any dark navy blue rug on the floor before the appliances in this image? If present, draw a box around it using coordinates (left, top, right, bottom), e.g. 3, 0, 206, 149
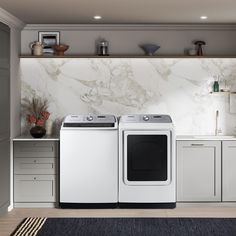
11, 218, 236, 236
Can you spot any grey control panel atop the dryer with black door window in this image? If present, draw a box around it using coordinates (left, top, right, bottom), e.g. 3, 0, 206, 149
120, 114, 172, 123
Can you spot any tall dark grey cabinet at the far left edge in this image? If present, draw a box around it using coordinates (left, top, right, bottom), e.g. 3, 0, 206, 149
0, 23, 10, 211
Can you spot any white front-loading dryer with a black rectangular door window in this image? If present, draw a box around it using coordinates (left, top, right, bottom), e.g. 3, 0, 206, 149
119, 115, 176, 208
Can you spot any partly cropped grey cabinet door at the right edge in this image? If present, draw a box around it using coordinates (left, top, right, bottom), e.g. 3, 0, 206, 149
222, 141, 236, 201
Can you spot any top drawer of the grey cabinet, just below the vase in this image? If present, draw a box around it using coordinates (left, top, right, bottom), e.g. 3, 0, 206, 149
14, 141, 58, 157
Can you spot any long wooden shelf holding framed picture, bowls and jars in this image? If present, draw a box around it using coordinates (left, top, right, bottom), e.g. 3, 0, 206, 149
20, 54, 236, 59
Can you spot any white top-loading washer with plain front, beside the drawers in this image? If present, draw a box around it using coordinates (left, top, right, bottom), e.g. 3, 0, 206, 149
59, 115, 118, 208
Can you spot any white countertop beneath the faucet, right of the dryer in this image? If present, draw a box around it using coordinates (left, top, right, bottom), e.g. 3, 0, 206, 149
176, 135, 236, 141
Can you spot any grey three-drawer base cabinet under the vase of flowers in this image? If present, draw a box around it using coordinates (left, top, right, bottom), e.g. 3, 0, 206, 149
14, 140, 59, 207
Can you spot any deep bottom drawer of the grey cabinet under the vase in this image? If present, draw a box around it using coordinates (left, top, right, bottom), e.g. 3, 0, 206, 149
14, 175, 56, 202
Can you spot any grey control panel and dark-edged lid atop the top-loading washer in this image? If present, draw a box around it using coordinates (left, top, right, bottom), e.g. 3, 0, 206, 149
63, 115, 116, 128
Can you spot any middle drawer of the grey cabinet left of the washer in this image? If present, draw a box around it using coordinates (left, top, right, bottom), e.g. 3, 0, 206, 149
14, 158, 56, 175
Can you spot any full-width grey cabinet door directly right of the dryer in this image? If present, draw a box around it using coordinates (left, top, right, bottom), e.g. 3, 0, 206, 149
177, 141, 221, 202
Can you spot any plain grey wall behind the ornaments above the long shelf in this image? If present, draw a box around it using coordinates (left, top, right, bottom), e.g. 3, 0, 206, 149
21, 25, 236, 55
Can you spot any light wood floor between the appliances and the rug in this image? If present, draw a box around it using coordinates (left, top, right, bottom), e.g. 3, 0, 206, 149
0, 207, 236, 236
